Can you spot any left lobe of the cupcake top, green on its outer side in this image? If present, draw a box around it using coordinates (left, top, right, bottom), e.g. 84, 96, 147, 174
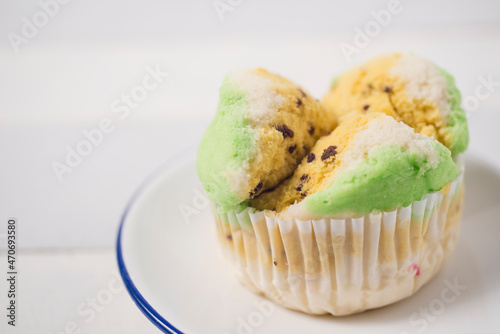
197, 69, 336, 210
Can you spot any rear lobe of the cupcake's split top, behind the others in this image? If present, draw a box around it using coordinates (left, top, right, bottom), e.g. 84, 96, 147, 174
324, 54, 469, 156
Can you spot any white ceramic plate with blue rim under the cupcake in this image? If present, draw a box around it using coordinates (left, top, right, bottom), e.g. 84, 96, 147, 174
117, 150, 500, 334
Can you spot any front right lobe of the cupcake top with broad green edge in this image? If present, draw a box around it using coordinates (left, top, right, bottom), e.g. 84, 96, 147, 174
251, 112, 459, 220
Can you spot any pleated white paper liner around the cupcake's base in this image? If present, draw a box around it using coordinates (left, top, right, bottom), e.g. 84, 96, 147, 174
214, 175, 463, 315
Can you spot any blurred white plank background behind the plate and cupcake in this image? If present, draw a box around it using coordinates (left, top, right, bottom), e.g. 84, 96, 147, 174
0, 0, 500, 333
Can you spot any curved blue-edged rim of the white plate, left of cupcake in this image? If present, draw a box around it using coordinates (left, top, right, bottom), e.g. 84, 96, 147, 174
116, 147, 196, 334
